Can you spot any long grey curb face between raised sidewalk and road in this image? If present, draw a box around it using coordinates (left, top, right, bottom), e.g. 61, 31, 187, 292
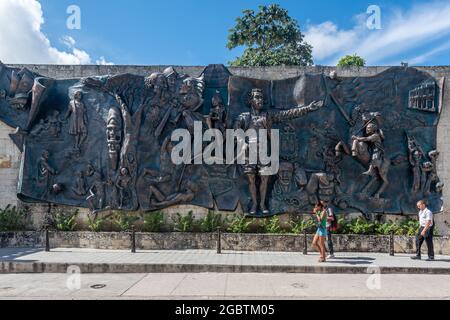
0, 261, 450, 275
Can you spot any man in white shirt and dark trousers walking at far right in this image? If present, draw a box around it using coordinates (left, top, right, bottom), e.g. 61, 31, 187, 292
411, 200, 434, 261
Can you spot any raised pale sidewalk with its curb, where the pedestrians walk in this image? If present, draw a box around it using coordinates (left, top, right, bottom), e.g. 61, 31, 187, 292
0, 248, 450, 274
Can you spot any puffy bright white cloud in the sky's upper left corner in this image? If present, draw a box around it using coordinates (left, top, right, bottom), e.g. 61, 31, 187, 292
0, 0, 112, 64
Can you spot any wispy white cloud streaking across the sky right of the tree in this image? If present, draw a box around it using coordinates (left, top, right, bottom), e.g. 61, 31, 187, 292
305, 2, 450, 64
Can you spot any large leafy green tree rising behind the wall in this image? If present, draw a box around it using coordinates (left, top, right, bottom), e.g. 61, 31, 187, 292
227, 4, 313, 67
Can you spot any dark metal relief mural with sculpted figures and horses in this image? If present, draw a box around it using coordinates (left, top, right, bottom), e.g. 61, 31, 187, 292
0, 64, 443, 217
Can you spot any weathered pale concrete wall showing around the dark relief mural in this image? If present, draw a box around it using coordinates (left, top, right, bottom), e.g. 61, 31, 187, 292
0, 65, 450, 234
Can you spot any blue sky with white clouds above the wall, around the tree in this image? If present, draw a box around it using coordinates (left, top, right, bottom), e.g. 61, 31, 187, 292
0, 0, 450, 66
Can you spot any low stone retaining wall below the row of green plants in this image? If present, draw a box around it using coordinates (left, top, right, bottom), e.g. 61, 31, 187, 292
0, 231, 450, 255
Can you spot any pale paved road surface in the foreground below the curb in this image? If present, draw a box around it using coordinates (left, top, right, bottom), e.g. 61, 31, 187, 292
0, 273, 450, 300
